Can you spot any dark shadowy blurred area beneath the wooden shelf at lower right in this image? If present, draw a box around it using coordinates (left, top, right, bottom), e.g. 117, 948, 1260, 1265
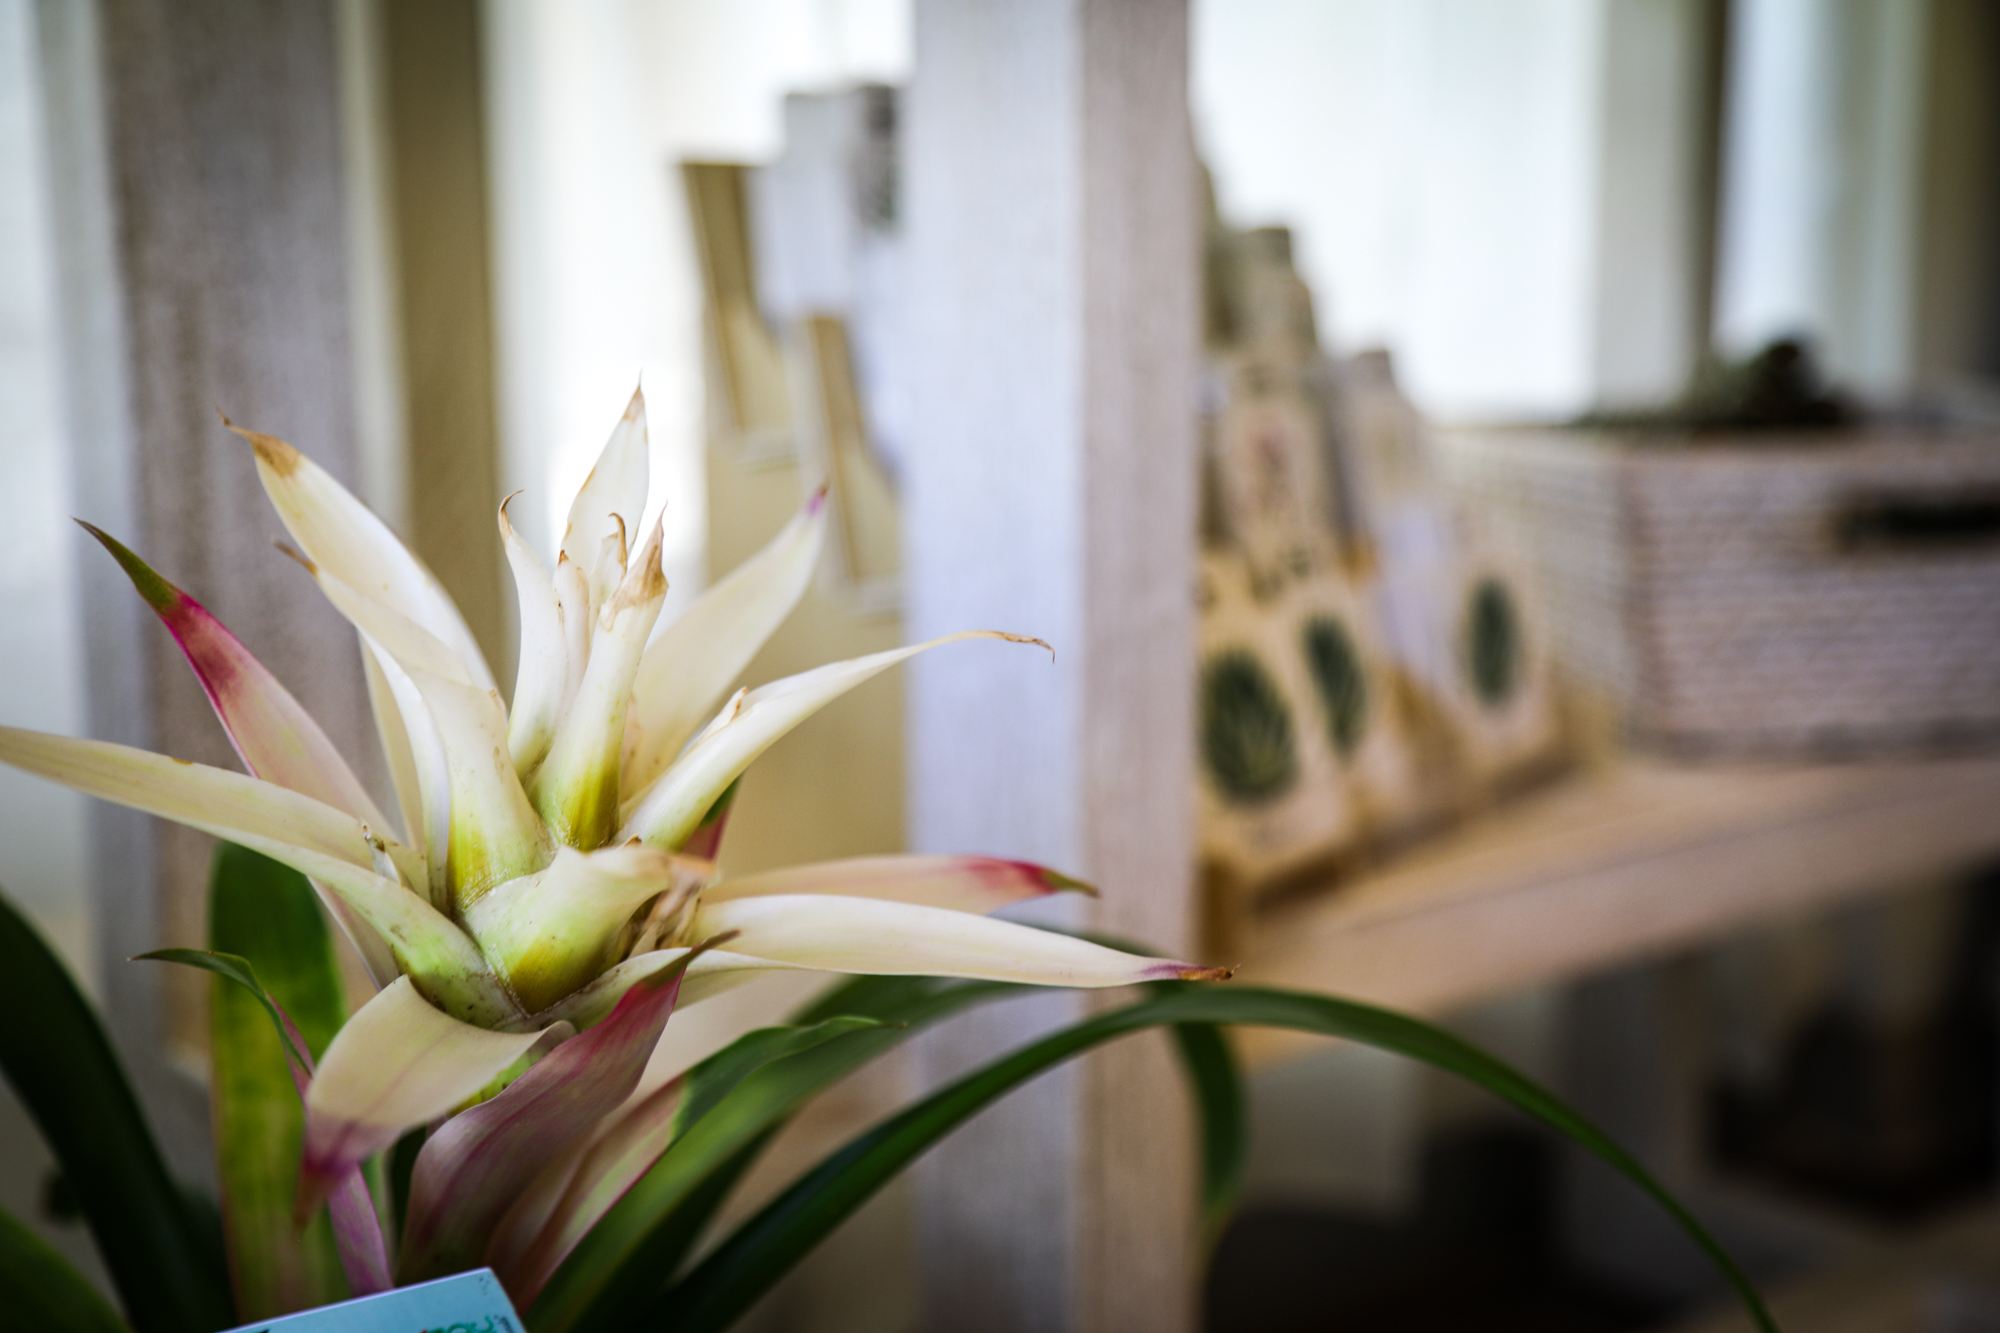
1206, 871, 2000, 1333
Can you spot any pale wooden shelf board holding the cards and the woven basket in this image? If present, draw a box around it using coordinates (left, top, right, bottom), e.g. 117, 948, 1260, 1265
1238, 757, 2000, 1061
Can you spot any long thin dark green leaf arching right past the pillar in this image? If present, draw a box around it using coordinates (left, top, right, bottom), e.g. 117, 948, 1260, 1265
656, 987, 1778, 1333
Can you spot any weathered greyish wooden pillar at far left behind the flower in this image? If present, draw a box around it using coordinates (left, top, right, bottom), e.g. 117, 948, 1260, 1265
38, 0, 372, 1175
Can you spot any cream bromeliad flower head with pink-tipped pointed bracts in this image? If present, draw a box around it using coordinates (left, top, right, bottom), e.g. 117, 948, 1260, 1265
0, 394, 1218, 1279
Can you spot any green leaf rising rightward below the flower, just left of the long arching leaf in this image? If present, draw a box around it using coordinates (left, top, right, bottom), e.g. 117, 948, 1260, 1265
528, 977, 1024, 1333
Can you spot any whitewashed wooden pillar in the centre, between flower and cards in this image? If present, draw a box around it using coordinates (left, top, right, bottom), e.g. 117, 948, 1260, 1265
904, 0, 1200, 1331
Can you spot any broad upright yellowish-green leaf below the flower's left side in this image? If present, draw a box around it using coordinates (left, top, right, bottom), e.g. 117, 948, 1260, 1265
208, 843, 348, 1319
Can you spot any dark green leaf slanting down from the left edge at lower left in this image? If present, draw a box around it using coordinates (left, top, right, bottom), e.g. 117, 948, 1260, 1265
0, 880, 236, 1333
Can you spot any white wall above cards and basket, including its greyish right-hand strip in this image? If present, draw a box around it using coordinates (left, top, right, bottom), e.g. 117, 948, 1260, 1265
1194, 0, 1698, 418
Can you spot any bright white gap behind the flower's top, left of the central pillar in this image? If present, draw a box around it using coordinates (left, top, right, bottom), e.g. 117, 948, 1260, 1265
482, 0, 910, 616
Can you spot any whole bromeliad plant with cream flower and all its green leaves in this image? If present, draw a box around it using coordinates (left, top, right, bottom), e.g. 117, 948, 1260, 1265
0, 396, 1772, 1333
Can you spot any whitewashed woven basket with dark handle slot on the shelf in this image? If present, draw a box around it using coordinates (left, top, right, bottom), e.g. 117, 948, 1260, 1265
1442, 430, 2000, 755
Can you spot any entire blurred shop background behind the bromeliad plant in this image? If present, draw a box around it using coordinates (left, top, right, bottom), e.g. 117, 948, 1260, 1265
0, 0, 2000, 1333
